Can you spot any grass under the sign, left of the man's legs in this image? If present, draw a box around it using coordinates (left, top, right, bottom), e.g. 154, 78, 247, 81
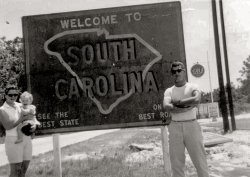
0, 128, 168, 177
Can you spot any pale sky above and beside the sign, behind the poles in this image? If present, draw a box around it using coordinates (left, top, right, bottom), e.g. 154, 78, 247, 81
0, 0, 250, 92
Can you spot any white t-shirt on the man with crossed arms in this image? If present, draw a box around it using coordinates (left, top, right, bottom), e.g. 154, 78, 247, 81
164, 82, 200, 121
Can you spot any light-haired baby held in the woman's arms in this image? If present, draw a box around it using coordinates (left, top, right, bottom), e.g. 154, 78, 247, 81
15, 92, 40, 144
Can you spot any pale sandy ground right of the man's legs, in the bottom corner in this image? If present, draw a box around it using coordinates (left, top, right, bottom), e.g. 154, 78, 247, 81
206, 130, 250, 177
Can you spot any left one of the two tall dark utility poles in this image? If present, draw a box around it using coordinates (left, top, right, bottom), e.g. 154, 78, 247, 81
212, 0, 229, 133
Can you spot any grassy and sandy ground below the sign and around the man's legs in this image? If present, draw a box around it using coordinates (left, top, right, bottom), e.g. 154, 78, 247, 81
0, 127, 250, 177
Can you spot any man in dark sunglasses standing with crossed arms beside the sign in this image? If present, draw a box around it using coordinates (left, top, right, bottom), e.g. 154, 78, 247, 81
163, 61, 209, 177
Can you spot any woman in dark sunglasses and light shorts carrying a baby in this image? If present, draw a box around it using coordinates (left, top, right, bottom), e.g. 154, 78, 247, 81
0, 85, 36, 177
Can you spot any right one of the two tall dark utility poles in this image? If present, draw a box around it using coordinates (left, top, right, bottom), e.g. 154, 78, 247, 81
219, 0, 236, 131
